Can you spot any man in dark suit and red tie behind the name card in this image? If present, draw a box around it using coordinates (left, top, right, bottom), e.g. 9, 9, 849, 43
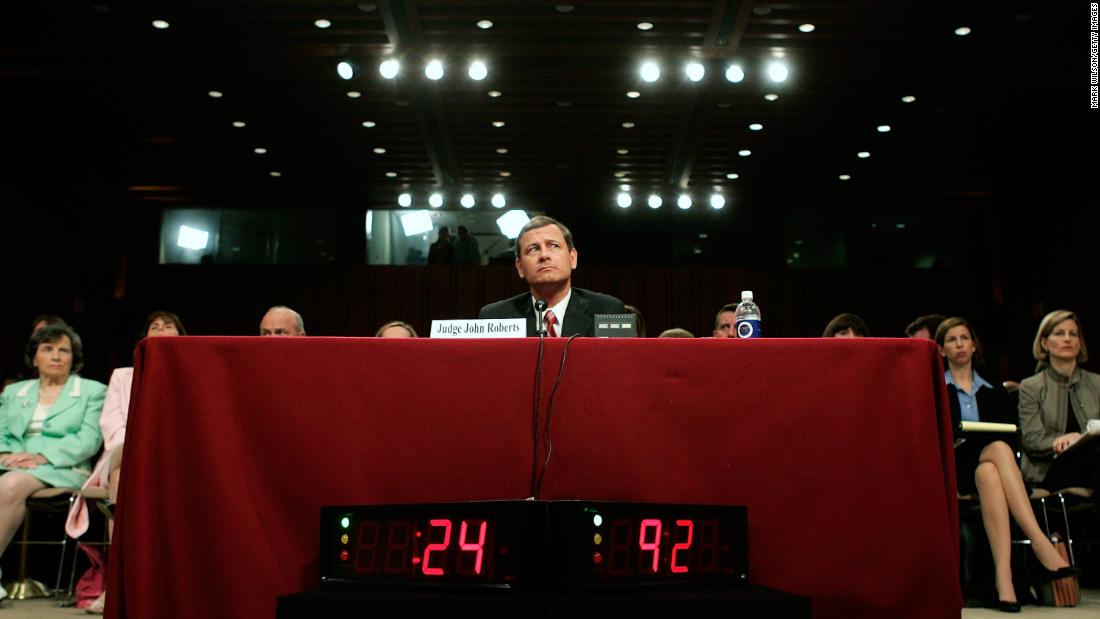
477, 215, 626, 338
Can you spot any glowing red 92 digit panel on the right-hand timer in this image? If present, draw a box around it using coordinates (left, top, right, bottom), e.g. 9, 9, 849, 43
606, 518, 718, 576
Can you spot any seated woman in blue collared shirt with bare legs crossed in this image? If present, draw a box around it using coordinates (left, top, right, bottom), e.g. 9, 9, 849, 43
935, 317, 1073, 612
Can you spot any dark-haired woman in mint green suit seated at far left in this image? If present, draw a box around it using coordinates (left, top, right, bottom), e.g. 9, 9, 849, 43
0, 324, 107, 599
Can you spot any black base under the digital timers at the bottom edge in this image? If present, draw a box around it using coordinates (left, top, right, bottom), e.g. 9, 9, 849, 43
275, 585, 811, 619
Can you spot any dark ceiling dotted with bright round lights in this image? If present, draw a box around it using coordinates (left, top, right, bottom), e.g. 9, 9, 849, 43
0, 0, 1082, 235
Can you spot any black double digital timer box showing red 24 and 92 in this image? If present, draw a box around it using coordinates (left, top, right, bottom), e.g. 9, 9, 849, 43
321, 501, 748, 588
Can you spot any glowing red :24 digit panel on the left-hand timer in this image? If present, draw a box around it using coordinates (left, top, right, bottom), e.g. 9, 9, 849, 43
354, 518, 490, 577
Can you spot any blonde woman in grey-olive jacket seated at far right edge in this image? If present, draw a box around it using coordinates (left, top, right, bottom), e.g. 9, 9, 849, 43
1020, 310, 1100, 500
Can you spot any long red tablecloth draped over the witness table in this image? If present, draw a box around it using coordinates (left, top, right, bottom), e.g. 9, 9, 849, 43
108, 338, 961, 619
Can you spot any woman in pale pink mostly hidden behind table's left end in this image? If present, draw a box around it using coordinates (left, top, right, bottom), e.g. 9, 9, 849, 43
65, 311, 187, 614
